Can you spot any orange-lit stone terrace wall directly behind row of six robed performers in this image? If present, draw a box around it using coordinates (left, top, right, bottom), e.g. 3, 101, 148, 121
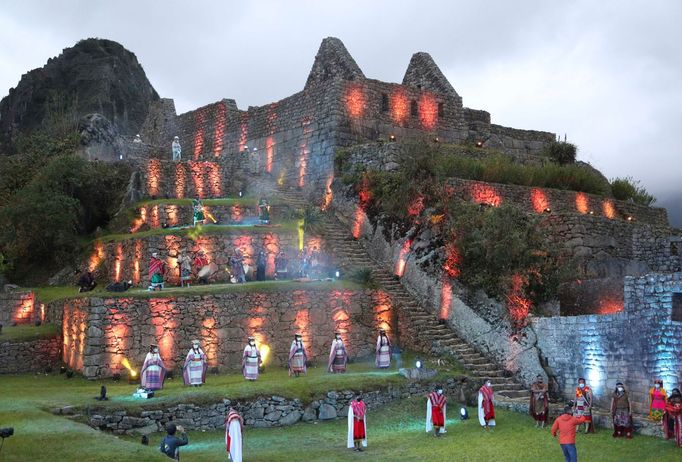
63, 286, 395, 378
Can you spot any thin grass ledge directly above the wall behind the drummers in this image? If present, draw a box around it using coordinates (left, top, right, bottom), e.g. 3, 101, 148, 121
95, 220, 298, 242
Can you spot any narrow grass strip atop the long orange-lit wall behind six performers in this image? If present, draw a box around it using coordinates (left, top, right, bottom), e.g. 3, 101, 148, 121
27, 280, 364, 304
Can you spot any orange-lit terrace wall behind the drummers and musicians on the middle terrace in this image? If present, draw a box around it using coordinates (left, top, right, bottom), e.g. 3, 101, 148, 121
87, 227, 325, 285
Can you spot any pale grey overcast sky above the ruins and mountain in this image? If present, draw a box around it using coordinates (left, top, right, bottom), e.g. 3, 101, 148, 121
0, 0, 682, 226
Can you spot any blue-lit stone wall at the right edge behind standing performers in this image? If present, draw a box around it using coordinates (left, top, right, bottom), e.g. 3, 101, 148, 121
532, 273, 682, 412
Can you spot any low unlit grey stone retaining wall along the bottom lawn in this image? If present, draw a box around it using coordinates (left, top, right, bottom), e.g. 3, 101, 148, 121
78, 376, 475, 434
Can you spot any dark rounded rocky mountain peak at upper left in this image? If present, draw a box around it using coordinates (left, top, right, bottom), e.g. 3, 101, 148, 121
0, 38, 159, 152
